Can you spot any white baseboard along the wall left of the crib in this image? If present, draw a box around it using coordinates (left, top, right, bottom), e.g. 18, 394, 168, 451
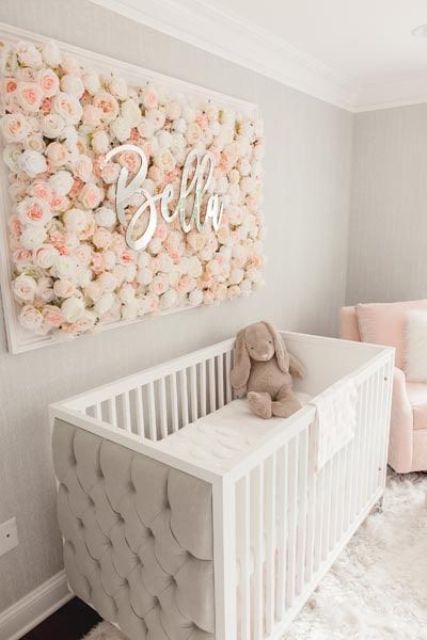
0, 571, 73, 640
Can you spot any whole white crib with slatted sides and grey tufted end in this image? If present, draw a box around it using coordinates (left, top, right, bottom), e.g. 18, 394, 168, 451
51, 333, 393, 640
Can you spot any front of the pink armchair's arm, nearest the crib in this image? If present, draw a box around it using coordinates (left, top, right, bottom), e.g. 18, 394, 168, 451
388, 367, 414, 473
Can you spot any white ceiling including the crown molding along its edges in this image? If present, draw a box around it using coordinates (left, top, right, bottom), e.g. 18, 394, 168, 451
93, 0, 427, 111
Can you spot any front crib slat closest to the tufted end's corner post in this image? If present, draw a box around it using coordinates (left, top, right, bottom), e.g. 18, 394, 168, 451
238, 476, 251, 640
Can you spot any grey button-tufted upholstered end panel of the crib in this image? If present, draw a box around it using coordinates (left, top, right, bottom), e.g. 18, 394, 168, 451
53, 420, 214, 640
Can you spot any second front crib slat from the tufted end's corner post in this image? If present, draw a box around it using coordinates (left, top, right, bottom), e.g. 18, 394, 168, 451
251, 464, 264, 640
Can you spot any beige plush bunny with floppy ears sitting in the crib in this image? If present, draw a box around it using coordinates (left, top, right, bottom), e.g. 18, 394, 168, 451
231, 322, 304, 418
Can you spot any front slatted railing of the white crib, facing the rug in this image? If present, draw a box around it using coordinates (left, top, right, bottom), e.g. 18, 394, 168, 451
217, 357, 393, 640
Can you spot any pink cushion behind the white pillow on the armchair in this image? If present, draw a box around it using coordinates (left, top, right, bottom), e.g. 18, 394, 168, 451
356, 300, 427, 369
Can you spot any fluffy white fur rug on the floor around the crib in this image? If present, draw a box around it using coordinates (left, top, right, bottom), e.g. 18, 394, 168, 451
85, 474, 427, 640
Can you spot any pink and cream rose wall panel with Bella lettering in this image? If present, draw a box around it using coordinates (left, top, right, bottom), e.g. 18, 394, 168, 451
0, 27, 263, 351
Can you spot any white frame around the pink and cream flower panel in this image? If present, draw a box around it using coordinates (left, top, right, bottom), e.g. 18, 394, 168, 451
0, 23, 259, 354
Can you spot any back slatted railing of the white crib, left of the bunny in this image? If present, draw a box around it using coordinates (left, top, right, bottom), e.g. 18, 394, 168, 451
68, 340, 233, 441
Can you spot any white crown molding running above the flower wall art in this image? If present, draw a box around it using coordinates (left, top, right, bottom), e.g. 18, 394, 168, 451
88, 0, 358, 111
